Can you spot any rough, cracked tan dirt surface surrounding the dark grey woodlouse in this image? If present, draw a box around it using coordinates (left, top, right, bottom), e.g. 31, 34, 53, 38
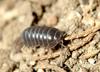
0, 0, 100, 72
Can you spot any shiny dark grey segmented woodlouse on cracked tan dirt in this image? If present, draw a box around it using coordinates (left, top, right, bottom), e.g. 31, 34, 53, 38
22, 26, 63, 48
